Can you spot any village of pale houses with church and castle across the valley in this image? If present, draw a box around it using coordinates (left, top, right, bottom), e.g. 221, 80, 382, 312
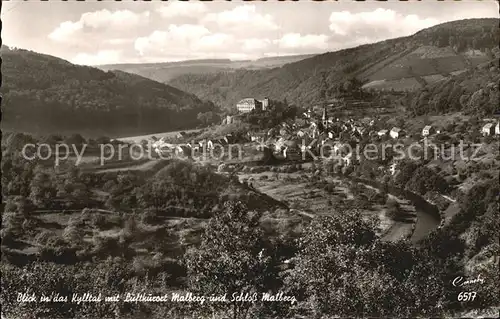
142, 97, 500, 171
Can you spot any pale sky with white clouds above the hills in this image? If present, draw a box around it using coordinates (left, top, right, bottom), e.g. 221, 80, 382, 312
1, 0, 499, 65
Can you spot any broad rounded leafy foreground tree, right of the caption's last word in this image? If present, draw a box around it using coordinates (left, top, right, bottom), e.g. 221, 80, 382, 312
285, 211, 418, 318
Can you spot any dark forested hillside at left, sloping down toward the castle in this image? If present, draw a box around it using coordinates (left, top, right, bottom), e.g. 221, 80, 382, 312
1, 47, 214, 135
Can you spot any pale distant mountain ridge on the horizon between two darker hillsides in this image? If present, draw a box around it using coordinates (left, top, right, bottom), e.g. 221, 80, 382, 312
96, 54, 314, 83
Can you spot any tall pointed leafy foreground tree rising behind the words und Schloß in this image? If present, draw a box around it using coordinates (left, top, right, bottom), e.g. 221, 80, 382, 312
186, 203, 277, 318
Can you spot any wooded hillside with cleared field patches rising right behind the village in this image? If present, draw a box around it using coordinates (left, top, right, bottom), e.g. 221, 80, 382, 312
170, 19, 500, 112
